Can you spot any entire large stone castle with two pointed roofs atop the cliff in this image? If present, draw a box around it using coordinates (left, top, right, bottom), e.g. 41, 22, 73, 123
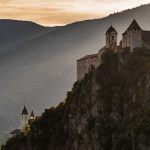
77, 19, 150, 80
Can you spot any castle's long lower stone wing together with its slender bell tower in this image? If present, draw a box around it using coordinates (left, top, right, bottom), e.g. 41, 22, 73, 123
77, 26, 118, 80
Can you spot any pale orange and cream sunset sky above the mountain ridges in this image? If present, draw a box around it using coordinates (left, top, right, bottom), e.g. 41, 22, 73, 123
0, 0, 150, 26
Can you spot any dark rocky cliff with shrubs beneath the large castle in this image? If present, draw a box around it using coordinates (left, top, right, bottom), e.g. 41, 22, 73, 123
3, 48, 150, 150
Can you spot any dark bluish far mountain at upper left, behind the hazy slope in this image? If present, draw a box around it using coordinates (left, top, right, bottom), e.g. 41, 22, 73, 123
0, 20, 53, 50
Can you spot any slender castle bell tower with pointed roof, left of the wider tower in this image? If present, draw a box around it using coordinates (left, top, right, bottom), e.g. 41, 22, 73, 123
106, 25, 118, 52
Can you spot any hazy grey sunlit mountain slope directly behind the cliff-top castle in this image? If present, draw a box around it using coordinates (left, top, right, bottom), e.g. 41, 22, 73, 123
0, 5, 150, 142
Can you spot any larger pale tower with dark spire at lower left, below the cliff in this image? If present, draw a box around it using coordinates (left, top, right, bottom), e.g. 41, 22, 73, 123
20, 106, 29, 130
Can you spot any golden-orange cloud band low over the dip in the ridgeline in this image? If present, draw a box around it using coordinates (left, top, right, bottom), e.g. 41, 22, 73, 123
0, 7, 103, 26
